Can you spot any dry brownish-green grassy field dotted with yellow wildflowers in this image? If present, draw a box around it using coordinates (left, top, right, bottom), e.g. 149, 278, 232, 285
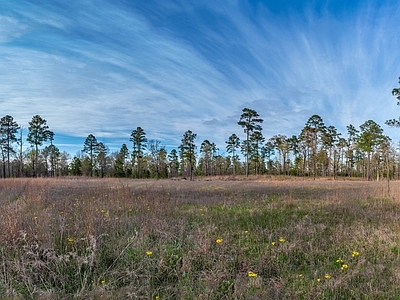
0, 177, 400, 299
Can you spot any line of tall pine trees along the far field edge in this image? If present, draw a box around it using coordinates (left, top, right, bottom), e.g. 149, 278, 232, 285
0, 78, 400, 180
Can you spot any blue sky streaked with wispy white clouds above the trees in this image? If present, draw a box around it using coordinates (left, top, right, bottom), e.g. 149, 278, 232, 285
0, 0, 400, 155
